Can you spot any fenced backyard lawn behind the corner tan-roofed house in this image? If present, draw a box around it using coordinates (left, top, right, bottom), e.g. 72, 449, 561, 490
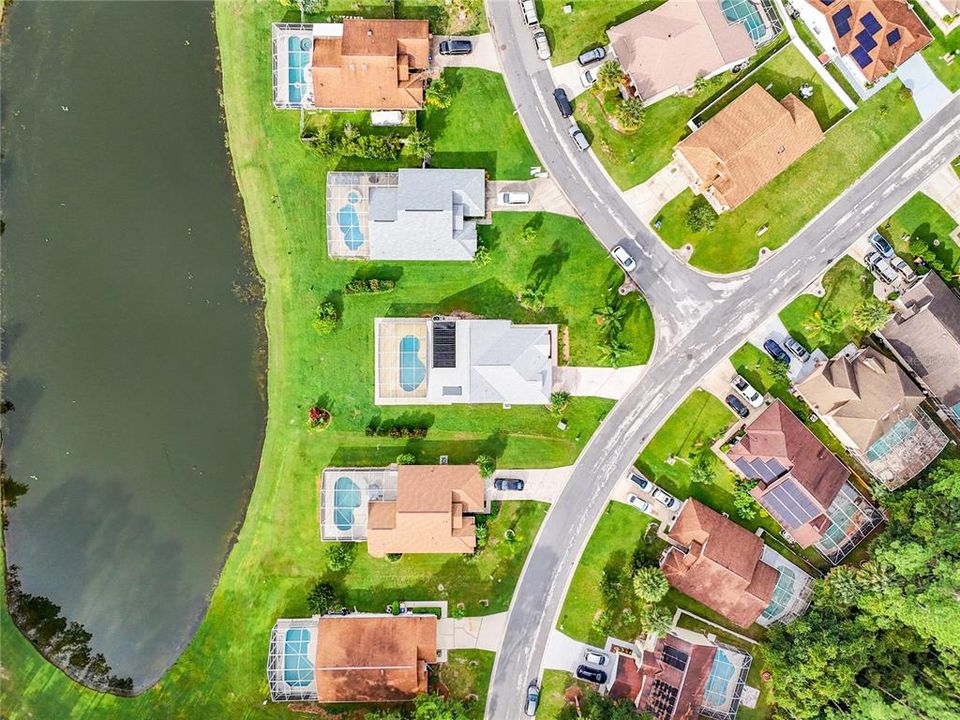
700, 43, 847, 130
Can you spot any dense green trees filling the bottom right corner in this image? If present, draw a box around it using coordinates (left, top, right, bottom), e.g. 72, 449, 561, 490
767, 460, 960, 720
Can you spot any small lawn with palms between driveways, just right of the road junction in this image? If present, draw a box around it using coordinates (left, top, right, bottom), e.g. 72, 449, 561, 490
780, 257, 874, 357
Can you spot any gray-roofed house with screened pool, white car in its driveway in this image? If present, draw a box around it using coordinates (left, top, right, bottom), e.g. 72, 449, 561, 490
327, 168, 487, 261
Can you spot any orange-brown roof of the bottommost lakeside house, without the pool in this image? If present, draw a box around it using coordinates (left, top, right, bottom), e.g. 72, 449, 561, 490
314, 615, 437, 702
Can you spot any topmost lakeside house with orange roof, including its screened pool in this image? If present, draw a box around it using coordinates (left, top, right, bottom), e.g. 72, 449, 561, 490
273, 18, 430, 110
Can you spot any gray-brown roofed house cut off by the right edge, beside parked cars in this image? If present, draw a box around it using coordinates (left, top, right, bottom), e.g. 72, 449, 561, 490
880, 272, 960, 430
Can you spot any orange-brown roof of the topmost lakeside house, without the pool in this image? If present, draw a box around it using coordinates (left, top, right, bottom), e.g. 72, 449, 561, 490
311, 19, 430, 110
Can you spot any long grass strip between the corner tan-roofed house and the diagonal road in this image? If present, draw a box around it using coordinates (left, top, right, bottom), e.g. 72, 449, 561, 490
660, 80, 920, 273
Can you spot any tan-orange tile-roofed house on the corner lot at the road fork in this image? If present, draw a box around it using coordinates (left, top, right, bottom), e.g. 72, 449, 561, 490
674, 85, 823, 212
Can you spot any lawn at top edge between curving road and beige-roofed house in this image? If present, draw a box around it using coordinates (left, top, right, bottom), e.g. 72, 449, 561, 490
537, 0, 666, 65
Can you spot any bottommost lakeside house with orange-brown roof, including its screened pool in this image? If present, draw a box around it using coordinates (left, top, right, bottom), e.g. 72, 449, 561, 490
267, 613, 438, 703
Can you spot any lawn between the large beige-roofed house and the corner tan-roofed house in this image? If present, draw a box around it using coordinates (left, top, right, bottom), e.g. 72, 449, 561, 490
573, 34, 789, 190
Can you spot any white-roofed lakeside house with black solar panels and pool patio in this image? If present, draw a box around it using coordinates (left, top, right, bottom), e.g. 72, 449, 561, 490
374, 316, 557, 405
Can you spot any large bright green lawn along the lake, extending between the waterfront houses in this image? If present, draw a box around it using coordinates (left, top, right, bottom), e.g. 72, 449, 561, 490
0, 1, 643, 719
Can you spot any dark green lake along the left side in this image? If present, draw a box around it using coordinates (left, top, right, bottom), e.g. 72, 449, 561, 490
0, 1, 270, 687
